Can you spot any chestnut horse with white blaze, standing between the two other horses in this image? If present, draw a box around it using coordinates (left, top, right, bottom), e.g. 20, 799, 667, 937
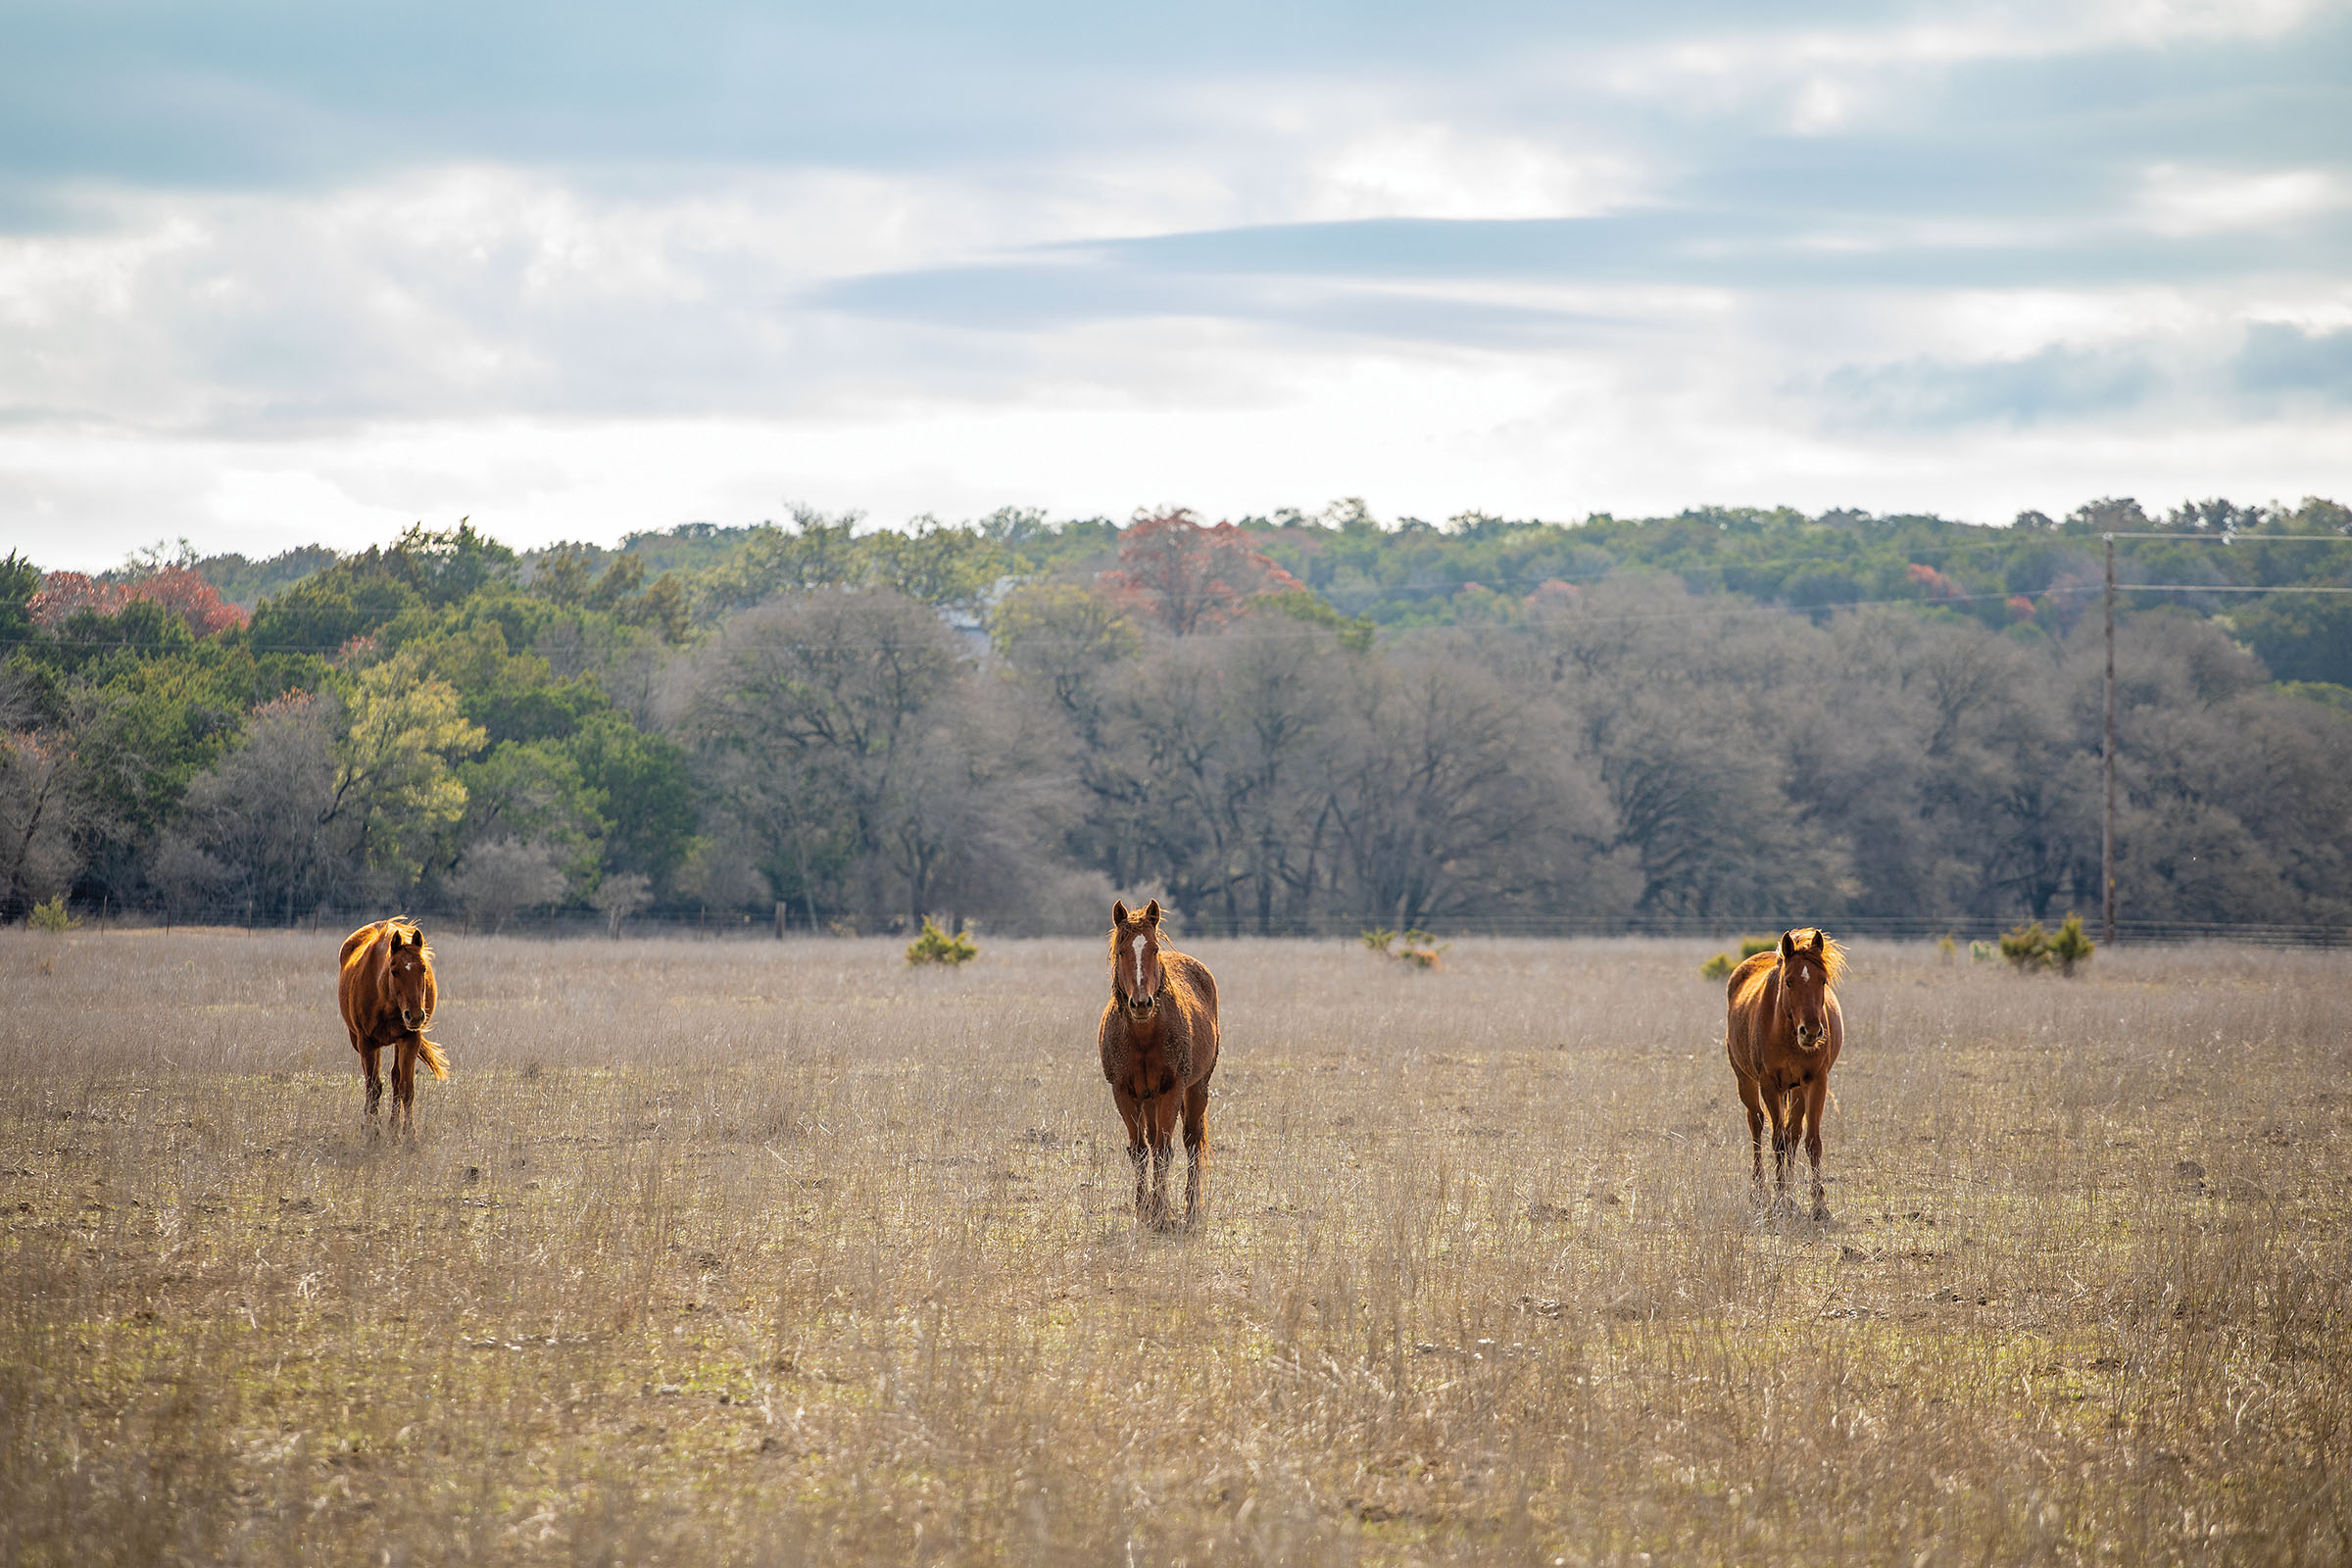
1096, 898, 1216, 1227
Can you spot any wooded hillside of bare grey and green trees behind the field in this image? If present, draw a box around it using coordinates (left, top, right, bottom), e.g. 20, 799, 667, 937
0, 501, 2352, 933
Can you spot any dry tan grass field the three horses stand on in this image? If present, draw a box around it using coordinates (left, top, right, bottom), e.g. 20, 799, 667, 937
0, 931, 2352, 1566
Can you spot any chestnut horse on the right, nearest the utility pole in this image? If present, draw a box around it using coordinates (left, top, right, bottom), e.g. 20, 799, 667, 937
1724, 926, 1846, 1220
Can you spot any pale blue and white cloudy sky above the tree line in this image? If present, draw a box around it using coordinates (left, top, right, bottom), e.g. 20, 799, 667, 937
0, 0, 2352, 566
